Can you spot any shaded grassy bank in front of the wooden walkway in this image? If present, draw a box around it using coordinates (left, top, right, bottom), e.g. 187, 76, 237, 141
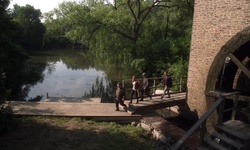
0, 117, 156, 150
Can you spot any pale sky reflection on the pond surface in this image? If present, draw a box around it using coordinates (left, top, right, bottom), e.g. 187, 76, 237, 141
28, 61, 106, 99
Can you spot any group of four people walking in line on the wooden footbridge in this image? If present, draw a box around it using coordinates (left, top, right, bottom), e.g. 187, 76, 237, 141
115, 71, 172, 111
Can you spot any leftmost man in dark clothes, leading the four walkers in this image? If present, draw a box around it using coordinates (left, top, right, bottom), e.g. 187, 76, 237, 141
115, 82, 127, 111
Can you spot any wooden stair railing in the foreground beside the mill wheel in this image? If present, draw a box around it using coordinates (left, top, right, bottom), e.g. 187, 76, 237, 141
171, 92, 239, 150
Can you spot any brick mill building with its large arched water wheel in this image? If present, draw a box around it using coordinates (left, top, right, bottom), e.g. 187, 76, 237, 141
186, 0, 250, 128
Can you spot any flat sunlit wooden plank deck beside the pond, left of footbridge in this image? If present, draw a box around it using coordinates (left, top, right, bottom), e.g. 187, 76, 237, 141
10, 101, 141, 123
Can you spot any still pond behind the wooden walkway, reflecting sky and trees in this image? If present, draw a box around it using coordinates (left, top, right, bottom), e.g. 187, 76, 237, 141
23, 50, 122, 101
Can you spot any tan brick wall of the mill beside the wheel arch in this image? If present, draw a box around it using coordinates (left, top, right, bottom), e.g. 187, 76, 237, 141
187, 0, 250, 117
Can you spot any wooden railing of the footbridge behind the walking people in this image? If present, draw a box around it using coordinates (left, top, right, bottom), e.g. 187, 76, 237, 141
122, 77, 187, 99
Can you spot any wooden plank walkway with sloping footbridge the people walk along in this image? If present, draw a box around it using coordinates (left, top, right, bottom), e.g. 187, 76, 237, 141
10, 93, 186, 121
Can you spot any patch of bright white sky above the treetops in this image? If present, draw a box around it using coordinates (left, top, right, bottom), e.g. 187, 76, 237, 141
9, 0, 76, 13
